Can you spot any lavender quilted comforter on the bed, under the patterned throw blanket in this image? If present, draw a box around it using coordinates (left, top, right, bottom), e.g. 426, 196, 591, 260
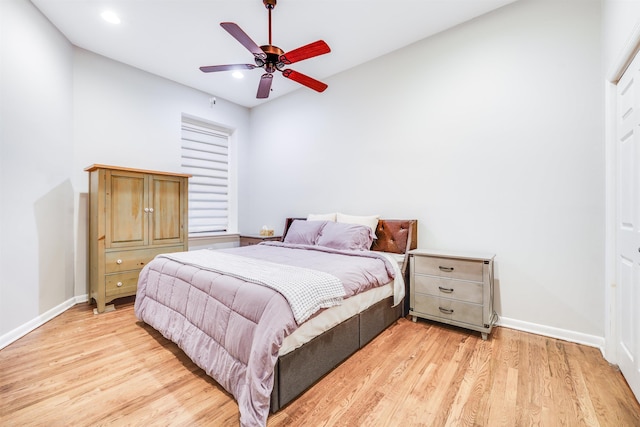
135, 243, 394, 426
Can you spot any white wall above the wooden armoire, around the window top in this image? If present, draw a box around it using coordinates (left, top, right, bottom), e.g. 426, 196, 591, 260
73, 48, 249, 186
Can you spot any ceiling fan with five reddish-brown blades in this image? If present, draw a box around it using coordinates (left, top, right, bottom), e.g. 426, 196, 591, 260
200, 0, 331, 98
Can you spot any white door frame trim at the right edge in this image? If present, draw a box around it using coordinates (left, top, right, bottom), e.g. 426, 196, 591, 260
602, 21, 640, 365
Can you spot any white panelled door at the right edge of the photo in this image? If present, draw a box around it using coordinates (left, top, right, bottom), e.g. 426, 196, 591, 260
616, 50, 640, 401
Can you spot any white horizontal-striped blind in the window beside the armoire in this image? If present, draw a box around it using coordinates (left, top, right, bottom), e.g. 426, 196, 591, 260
182, 117, 229, 236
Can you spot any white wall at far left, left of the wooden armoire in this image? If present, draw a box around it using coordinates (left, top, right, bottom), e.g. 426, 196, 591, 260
0, 0, 74, 336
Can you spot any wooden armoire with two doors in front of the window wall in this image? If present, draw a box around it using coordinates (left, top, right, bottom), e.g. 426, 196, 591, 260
85, 165, 190, 313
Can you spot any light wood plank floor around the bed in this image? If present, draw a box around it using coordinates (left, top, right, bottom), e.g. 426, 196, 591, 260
0, 300, 640, 427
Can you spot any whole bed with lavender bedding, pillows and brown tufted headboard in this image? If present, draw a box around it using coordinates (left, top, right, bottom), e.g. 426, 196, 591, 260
135, 218, 417, 426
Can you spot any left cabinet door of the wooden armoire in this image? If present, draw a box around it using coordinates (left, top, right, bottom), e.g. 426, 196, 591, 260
105, 171, 149, 248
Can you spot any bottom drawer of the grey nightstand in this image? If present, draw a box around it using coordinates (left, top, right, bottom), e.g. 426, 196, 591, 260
413, 294, 483, 326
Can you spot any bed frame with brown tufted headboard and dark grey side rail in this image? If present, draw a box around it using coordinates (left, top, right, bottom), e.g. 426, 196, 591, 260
271, 218, 418, 412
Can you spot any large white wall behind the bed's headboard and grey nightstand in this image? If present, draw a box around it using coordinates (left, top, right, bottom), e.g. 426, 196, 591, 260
245, 0, 605, 345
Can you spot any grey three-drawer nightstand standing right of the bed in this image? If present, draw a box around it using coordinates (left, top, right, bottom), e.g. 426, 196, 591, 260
409, 249, 497, 340
